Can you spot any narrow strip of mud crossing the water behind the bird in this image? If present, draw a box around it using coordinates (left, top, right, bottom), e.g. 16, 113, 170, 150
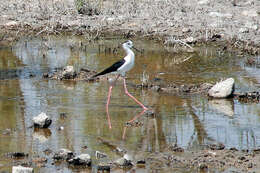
42, 66, 260, 103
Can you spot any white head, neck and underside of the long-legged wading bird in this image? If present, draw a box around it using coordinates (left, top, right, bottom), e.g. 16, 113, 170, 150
117, 41, 135, 76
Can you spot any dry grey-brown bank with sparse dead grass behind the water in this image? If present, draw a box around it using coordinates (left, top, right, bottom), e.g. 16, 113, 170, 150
0, 0, 260, 54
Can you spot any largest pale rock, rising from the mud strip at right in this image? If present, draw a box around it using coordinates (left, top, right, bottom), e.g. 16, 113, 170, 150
208, 78, 235, 98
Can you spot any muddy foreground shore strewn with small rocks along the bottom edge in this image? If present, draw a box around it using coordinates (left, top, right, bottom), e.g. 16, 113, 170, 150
3, 138, 260, 173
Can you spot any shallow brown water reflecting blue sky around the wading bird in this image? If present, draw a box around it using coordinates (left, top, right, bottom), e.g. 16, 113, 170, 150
0, 37, 260, 172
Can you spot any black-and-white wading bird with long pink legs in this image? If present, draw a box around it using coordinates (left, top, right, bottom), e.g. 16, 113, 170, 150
92, 40, 148, 128
